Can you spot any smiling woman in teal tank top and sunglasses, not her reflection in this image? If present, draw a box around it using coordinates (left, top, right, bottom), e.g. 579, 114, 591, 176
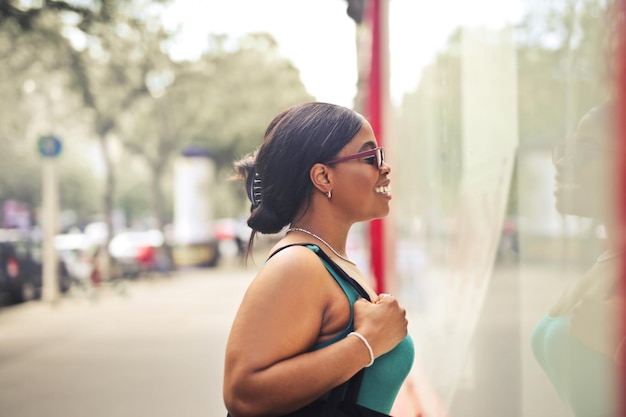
224, 103, 414, 417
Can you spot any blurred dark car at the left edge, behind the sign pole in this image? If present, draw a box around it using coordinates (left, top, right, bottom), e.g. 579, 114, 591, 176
0, 230, 71, 305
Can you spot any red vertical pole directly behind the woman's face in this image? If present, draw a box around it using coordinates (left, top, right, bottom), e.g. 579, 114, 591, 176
366, 0, 385, 293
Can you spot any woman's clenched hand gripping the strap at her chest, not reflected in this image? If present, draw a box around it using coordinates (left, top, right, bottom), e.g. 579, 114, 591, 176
354, 294, 408, 357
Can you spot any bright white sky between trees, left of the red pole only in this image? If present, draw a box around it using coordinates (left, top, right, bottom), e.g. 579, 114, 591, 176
165, 0, 357, 107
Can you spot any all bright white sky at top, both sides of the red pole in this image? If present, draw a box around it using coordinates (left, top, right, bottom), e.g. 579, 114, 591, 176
165, 0, 522, 107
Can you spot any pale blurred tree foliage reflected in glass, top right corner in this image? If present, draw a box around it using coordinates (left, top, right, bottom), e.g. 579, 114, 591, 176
517, 0, 619, 146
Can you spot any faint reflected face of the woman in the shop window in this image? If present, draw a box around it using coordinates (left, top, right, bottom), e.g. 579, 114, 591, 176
553, 111, 615, 221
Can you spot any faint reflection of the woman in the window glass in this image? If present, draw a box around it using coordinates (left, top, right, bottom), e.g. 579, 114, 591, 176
532, 103, 624, 417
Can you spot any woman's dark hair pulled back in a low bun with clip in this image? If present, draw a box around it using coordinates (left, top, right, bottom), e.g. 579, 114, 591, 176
235, 102, 364, 248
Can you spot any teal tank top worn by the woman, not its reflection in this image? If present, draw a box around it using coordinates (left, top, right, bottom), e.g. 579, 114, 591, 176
306, 245, 415, 414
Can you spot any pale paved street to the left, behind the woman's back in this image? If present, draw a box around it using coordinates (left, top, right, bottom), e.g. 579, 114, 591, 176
0, 266, 254, 417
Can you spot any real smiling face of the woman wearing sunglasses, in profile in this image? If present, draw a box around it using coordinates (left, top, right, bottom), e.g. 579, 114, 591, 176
332, 121, 391, 222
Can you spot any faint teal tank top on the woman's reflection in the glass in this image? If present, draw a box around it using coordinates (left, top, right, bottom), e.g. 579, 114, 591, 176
531, 314, 618, 417
